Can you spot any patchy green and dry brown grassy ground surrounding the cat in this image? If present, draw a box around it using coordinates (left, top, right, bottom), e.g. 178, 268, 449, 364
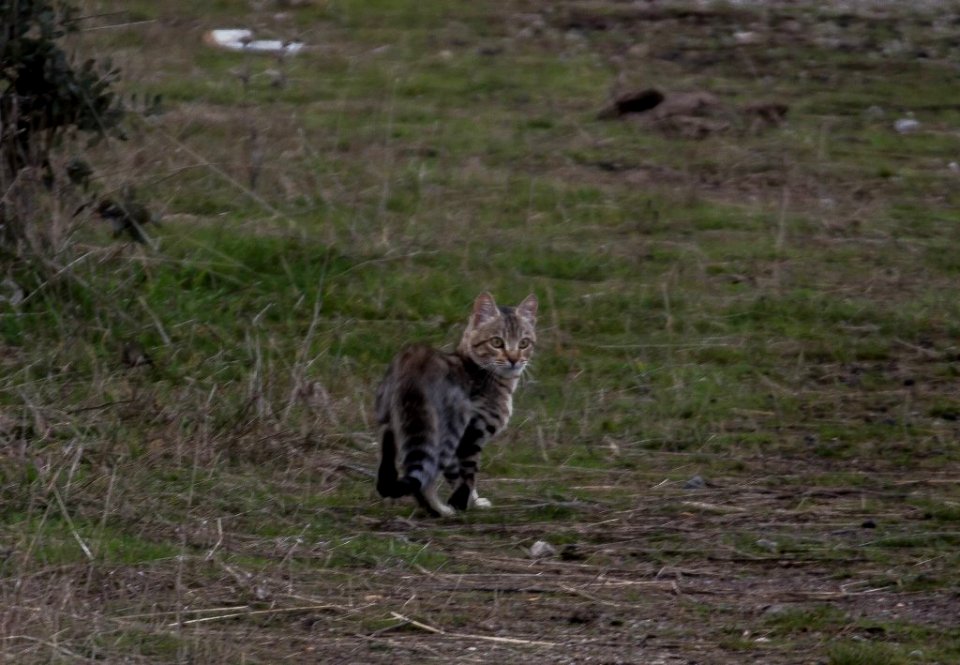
0, 0, 960, 664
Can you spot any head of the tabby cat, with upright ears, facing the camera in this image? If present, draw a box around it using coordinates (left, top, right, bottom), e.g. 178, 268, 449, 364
460, 293, 537, 378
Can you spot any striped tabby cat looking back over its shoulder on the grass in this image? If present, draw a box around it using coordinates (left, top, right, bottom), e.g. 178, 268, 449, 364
376, 293, 537, 517
